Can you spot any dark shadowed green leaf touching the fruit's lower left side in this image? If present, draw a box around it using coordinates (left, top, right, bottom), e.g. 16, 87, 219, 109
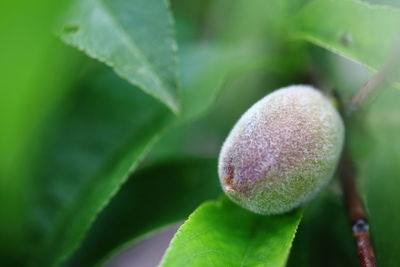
65, 159, 221, 267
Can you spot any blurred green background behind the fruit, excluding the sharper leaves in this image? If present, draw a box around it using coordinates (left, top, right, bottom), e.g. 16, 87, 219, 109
0, 0, 400, 266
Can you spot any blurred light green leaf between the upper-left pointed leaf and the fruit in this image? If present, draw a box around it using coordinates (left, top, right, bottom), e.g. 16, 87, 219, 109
175, 42, 264, 123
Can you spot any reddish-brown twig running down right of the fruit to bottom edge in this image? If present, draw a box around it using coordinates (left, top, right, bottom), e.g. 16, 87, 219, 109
339, 151, 376, 267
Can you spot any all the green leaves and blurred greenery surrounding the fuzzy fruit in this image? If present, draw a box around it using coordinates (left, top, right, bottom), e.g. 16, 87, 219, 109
0, 0, 400, 267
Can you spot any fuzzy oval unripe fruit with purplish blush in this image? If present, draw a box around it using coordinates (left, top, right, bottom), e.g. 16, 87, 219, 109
218, 85, 344, 214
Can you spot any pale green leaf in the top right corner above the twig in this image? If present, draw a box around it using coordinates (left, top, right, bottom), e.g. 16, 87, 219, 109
295, 0, 400, 76
